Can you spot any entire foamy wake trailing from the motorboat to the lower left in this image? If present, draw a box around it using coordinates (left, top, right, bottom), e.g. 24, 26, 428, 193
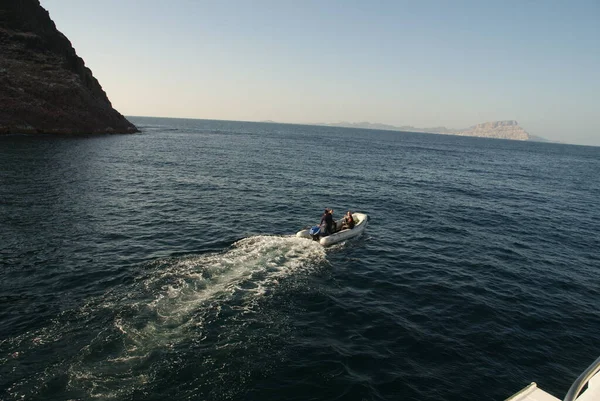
2, 236, 326, 399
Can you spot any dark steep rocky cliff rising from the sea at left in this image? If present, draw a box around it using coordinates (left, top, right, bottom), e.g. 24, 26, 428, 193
0, 0, 137, 134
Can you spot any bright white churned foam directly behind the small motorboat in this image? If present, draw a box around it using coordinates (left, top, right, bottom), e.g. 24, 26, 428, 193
137, 236, 325, 330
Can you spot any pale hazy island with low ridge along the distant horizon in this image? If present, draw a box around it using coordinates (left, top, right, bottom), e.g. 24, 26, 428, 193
317, 120, 547, 142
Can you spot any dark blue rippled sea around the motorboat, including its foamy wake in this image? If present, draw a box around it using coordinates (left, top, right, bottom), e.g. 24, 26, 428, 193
0, 117, 600, 401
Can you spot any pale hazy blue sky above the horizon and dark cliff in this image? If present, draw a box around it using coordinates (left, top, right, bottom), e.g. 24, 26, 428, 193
41, 0, 600, 145
